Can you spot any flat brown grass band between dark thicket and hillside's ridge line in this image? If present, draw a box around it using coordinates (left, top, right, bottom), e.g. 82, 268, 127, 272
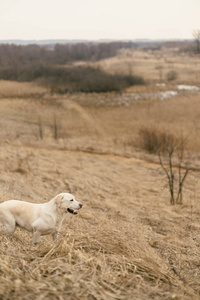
0, 87, 200, 155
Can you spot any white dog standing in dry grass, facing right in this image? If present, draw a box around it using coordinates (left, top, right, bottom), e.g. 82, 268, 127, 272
0, 193, 82, 245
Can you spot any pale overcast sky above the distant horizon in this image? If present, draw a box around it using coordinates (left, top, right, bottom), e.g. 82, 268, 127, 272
0, 0, 200, 40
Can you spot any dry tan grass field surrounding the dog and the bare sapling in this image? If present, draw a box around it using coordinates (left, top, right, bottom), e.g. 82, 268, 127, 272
0, 49, 200, 300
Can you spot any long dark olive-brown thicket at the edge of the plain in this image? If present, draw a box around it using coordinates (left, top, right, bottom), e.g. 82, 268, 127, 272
0, 65, 144, 93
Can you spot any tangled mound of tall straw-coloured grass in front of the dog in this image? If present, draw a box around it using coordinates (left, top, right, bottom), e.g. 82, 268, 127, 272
0, 214, 180, 299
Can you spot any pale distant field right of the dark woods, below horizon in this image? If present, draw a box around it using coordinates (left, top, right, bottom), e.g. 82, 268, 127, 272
90, 49, 200, 84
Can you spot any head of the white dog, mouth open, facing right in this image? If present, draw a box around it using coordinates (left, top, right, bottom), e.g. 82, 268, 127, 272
54, 193, 83, 214
